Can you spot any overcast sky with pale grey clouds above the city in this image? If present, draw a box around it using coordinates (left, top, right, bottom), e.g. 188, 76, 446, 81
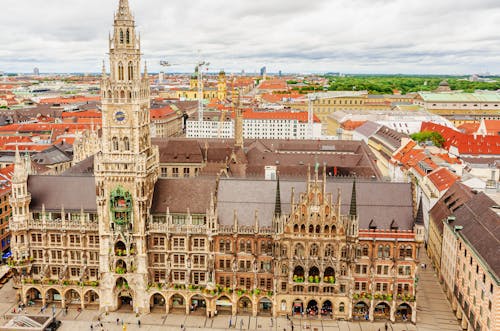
0, 0, 500, 74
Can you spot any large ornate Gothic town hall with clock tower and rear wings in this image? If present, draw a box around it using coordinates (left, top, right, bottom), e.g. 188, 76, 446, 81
6, 0, 422, 321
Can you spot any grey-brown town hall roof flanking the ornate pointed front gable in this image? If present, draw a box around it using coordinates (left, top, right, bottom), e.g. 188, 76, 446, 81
217, 179, 414, 230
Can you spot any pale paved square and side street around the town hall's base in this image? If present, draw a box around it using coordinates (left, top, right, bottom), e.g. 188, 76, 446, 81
0, 252, 461, 331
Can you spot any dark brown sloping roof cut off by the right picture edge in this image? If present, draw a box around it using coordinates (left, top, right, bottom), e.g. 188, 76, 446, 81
450, 192, 500, 278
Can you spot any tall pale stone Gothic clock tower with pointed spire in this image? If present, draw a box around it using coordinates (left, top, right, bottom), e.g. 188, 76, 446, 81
94, 0, 159, 312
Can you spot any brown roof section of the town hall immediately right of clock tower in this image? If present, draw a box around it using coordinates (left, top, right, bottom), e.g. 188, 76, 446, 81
151, 177, 216, 214
